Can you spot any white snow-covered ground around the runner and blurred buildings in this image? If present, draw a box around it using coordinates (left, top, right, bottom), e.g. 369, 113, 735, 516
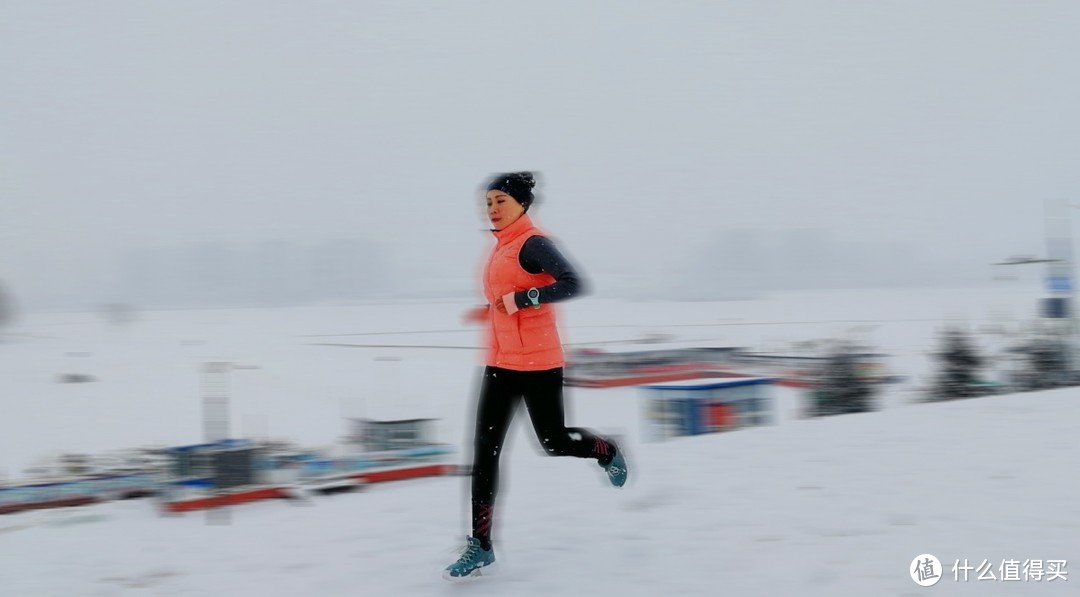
0, 287, 1080, 596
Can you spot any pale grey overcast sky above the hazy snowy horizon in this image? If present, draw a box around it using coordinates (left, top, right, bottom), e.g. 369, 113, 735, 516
0, 0, 1080, 302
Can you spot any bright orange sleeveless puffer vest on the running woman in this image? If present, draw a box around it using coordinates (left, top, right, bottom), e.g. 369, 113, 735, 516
484, 215, 564, 371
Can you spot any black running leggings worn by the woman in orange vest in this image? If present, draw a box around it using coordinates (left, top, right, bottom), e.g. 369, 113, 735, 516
472, 367, 615, 547
